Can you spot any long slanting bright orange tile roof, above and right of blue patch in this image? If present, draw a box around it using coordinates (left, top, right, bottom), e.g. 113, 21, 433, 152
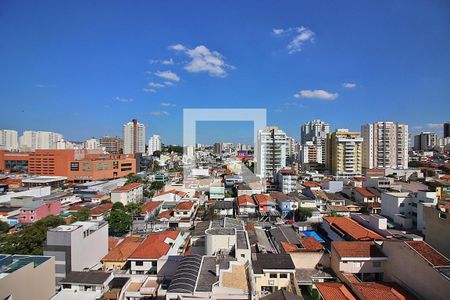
323, 217, 383, 241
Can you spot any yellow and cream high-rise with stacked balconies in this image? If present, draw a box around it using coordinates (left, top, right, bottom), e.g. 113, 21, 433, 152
326, 129, 363, 177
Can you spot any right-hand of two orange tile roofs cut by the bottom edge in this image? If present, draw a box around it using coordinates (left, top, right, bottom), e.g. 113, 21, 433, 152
351, 282, 416, 300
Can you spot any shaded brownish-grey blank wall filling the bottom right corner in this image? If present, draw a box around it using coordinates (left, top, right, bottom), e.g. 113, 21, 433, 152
383, 240, 450, 300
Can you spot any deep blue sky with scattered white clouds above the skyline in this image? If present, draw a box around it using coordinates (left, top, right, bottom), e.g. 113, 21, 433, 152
0, 0, 450, 144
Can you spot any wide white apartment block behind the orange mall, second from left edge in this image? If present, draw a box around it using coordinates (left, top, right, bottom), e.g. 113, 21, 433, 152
19, 131, 63, 151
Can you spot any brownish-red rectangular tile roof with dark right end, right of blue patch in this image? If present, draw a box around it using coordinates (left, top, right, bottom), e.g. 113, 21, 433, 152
331, 241, 385, 257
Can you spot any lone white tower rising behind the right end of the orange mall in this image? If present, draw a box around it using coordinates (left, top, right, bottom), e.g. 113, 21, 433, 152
123, 119, 145, 154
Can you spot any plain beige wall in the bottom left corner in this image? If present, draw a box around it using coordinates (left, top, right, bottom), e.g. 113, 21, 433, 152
0, 257, 55, 300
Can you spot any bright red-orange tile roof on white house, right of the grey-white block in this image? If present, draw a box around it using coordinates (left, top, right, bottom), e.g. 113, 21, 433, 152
130, 230, 180, 259
